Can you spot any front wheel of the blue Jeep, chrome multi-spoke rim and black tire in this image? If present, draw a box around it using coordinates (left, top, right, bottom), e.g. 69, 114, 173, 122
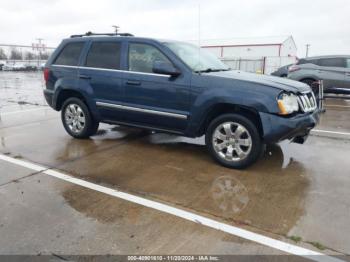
205, 114, 264, 169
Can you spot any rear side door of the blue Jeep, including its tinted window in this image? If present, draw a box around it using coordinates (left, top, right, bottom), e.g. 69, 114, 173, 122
79, 40, 124, 121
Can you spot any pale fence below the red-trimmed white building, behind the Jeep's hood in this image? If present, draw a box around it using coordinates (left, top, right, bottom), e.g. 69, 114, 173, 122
221, 56, 296, 74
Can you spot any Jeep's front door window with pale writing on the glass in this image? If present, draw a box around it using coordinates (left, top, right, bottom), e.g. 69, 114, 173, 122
129, 44, 171, 73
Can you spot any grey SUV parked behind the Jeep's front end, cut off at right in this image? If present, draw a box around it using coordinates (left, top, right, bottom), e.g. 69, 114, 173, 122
288, 55, 350, 94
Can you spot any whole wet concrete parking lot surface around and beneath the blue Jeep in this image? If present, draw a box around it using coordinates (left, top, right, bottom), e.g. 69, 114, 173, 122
0, 72, 350, 260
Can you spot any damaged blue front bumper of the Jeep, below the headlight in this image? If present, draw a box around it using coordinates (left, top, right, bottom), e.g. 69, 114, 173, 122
259, 110, 320, 143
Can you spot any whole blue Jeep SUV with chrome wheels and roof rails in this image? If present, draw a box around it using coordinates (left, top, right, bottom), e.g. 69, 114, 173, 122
44, 33, 319, 168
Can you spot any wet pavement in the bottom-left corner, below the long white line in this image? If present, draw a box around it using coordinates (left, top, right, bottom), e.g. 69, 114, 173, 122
0, 160, 281, 255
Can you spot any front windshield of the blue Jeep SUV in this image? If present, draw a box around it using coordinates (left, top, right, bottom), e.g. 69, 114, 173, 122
164, 42, 230, 72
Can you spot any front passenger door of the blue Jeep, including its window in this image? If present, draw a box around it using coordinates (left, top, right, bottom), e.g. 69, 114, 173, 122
122, 42, 190, 132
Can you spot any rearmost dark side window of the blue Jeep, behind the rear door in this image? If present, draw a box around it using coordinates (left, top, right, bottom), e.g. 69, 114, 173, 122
54, 42, 84, 66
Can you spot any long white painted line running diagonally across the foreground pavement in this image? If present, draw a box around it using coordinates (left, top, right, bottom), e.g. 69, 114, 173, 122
0, 154, 343, 262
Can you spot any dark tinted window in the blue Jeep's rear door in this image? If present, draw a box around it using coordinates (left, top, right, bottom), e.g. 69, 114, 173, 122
85, 42, 120, 69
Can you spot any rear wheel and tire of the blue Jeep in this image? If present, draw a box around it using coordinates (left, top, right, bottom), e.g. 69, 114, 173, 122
61, 97, 99, 139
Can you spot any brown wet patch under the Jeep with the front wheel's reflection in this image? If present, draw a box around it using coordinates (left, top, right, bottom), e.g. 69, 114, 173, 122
57, 131, 309, 233
